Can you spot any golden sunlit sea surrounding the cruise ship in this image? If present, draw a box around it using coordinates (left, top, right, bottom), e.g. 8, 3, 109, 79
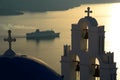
0, 3, 120, 80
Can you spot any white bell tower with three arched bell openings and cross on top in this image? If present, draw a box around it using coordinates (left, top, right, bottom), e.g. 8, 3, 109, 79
61, 7, 117, 80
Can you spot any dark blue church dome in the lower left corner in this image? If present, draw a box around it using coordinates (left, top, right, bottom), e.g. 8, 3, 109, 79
0, 50, 61, 80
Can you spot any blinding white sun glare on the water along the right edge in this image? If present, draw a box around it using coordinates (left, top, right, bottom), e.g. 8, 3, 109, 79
107, 3, 120, 78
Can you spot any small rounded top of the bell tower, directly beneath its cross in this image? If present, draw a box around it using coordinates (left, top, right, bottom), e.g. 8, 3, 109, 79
78, 16, 98, 27
